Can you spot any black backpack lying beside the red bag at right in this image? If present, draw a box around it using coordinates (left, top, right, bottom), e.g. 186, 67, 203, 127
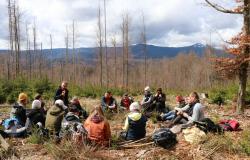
194, 118, 223, 133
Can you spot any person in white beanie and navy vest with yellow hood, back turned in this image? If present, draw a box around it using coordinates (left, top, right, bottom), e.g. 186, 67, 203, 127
122, 102, 147, 140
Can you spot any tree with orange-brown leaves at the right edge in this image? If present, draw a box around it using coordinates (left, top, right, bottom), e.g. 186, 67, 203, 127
205, 0, 250, 114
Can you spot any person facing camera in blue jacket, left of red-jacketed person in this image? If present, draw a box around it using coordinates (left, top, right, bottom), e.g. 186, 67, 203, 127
101, 91, 118, 112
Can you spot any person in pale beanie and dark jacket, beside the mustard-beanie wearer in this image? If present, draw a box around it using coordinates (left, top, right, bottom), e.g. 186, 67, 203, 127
27, 99, 45, 126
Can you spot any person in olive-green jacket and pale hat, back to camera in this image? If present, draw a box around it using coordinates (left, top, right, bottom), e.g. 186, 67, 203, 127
45, 99, 67, 136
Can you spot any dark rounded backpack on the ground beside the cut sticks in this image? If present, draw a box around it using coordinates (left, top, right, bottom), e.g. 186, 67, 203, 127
152, 128, 177, 149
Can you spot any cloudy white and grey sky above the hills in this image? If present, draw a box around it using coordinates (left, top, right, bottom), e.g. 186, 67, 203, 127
0, 0, 242, 48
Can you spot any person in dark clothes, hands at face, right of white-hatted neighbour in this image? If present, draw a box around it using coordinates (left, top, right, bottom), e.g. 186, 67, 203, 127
152, 88, 166, 113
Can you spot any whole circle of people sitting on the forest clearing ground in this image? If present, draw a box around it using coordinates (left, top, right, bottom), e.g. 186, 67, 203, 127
0, 82, 204, 146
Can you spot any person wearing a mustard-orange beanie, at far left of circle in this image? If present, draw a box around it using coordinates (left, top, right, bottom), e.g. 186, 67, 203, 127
10, 93, 28, 126
